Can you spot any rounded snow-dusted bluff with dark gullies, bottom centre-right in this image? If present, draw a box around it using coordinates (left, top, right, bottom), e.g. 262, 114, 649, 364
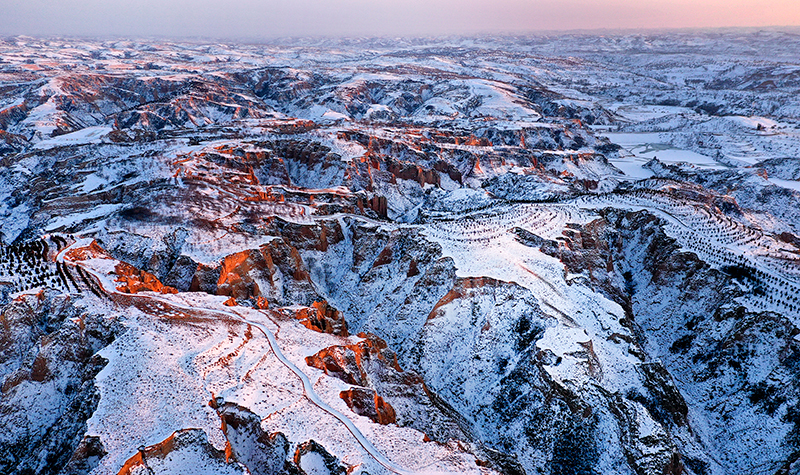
419, 279, 682, 473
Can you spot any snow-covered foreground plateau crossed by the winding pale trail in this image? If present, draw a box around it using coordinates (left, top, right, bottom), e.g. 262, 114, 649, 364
69, 249, 490, 475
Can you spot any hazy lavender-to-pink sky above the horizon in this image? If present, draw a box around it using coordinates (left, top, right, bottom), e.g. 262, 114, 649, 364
0, 0, 800, 38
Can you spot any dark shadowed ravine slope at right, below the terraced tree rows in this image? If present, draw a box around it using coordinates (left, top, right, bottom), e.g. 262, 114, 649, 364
542, 210, 798, 473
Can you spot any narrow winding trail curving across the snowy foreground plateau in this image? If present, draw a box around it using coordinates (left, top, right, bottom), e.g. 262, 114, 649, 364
56, 243, 418, 475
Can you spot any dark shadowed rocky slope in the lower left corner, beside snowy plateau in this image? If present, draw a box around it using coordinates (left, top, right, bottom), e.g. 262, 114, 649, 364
0, 291, 119, 474
